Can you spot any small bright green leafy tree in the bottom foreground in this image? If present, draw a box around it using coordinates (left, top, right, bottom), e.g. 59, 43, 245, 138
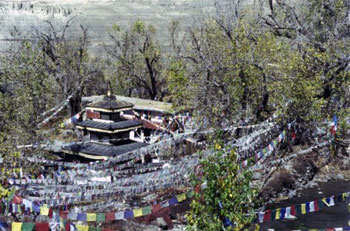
187, 138, 260, 231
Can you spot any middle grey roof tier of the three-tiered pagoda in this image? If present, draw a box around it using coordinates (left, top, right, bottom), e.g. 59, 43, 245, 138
74, 120, 143, 133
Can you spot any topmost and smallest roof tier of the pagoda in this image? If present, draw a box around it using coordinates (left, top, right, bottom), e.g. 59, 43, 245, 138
86, 95, 134, 112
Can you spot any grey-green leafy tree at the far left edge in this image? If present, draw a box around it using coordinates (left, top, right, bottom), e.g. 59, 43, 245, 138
0, 40, 54, 144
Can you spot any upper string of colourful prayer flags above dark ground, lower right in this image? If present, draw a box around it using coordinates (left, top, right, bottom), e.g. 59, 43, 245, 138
258, 192, 350, 223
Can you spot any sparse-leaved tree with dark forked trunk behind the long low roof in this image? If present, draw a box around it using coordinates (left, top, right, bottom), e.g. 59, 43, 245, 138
105, 21, 164, 100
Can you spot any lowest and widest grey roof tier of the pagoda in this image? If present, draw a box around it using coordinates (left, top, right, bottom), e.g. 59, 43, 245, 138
62, 142, 149, 159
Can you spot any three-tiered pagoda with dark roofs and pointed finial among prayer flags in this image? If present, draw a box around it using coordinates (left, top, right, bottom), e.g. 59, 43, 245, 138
62, 89, 148, 160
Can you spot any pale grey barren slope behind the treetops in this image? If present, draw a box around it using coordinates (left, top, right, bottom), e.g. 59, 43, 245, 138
0, 0, 215, 52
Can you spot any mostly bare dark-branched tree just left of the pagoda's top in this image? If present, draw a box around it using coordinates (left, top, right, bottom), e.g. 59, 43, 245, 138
33, 18, 98, 115
